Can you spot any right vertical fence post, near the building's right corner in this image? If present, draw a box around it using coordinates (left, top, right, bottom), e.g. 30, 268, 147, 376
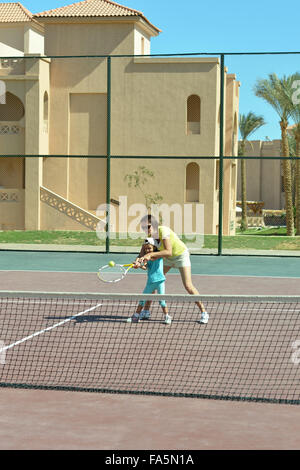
218, 54, 225, 256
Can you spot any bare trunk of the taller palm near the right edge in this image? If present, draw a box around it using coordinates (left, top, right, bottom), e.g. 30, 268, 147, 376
280, 121, 294, 237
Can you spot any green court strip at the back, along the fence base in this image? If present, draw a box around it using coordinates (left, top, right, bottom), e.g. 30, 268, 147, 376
0, 251, 300, 278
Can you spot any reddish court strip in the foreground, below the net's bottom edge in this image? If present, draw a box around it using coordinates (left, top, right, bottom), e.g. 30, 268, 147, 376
0, 389, 300, 450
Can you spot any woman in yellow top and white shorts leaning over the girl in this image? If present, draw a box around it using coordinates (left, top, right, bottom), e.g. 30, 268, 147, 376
136, 214, 209, 323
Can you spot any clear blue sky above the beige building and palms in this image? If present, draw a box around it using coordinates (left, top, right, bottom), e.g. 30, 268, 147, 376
11, 0, 300, 140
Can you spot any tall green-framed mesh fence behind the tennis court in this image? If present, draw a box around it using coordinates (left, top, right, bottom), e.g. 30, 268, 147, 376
0, 52, 300, 256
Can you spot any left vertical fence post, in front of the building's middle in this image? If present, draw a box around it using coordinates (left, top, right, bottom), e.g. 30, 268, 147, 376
105, 56, 111, 253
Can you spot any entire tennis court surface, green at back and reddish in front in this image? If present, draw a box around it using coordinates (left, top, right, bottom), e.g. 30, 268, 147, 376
0, 253, 300, 450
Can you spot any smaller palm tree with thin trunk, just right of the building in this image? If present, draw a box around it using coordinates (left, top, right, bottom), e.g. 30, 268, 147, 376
239, 111, 265, 230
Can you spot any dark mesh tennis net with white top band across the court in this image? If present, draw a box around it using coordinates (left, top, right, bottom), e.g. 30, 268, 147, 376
0, 292, 300, 404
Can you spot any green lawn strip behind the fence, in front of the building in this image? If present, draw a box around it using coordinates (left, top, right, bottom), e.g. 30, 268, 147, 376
0, 227, 300, 251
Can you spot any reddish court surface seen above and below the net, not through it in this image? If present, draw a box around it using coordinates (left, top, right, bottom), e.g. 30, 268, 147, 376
0, 272, 300, 451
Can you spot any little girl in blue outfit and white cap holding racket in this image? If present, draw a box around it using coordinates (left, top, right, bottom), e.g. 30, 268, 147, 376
131, 238, 172, 325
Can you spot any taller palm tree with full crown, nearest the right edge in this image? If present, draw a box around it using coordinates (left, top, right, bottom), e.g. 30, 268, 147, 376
254, 73, 295, 236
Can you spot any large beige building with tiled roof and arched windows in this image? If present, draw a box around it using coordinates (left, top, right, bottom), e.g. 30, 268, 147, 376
0, 0, 239, 234
